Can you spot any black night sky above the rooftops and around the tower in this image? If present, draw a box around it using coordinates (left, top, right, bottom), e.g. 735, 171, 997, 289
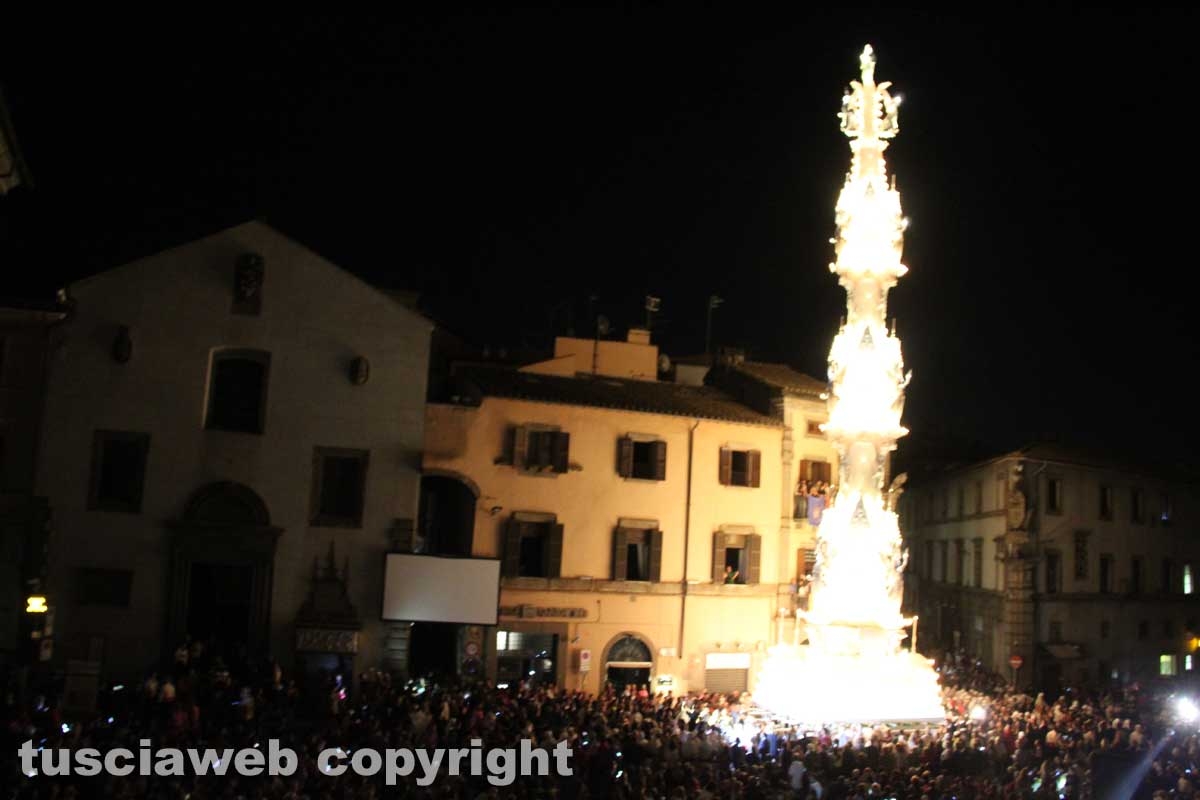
0, 5, 1200, 459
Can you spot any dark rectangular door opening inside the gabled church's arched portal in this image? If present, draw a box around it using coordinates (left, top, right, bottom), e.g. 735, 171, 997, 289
187, 564, 254, 660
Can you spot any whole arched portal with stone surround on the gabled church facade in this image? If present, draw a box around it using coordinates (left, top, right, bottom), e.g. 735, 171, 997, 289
164, 482, 282, 668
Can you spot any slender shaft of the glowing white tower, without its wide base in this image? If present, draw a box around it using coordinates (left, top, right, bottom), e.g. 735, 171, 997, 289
809, 46, 910, 628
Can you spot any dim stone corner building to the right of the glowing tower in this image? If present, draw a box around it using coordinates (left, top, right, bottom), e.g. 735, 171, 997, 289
900, 445, 1200, 691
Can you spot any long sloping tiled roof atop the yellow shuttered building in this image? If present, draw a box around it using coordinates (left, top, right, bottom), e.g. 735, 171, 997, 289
455, 366, 780, 427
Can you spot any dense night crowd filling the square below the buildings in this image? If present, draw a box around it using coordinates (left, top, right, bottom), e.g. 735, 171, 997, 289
7, 656, 1200, 800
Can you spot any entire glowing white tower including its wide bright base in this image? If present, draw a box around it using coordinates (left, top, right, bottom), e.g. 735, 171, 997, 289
756, 46, 943, 722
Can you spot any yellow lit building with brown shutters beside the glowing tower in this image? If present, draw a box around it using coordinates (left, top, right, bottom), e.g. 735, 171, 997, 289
414, 331, 832, 692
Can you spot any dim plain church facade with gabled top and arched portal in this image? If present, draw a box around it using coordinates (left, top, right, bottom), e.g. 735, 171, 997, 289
36, 222, 432, 693
